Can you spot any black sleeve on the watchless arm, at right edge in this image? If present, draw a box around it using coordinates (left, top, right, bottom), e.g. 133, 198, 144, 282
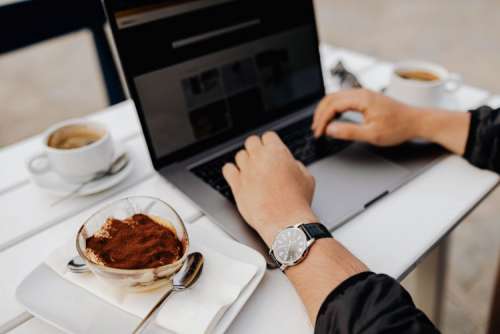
464, 106, 500, 173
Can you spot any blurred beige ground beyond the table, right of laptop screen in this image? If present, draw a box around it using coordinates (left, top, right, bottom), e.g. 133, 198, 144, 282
315, 0, 500, 92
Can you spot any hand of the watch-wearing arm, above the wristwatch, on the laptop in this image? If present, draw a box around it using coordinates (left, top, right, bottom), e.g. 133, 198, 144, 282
222, 132, 316, 246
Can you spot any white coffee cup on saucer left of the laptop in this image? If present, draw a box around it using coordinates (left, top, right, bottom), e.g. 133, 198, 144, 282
27, 119, 115, 184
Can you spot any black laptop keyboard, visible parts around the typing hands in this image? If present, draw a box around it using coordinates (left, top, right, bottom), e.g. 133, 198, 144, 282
191, 118, 349, 202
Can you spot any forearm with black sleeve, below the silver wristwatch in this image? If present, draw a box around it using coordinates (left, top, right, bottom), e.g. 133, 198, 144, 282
278, 226, 438, 334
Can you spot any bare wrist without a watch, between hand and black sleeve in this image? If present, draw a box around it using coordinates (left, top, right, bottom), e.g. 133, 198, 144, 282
414, 108, 470, 155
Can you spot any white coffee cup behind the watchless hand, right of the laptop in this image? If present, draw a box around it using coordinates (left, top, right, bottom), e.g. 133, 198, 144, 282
385, 61, 462, 107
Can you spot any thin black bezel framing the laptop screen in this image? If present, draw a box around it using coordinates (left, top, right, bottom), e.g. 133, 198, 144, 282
102, 0, 325, 170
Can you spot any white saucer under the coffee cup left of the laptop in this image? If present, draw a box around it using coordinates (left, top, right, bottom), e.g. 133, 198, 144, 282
28, 149, 133, 196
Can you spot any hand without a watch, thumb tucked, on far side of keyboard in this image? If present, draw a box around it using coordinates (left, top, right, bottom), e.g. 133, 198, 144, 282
312, 89, 418, 146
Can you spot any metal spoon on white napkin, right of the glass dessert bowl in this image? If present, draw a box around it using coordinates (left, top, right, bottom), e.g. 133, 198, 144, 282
132, 253, 203, 334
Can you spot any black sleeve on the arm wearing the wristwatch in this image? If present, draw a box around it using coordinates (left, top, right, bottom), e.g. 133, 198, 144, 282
315, 272, 439, 334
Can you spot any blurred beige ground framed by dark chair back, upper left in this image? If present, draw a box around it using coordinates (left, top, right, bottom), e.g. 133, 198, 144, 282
0, 32, 106, 147
